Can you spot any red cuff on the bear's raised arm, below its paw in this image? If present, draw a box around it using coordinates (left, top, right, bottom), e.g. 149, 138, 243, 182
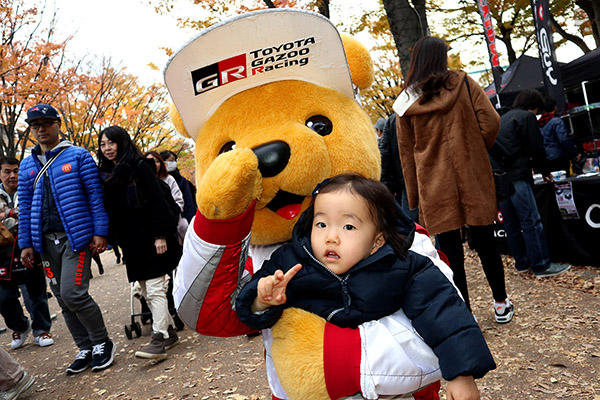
194, 200, 256, 245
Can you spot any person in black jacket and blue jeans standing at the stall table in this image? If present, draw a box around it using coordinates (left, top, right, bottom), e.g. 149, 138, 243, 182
490, 89, 570, 277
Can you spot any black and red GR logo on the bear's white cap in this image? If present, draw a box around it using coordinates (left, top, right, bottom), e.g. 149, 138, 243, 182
192, 54, 246, 96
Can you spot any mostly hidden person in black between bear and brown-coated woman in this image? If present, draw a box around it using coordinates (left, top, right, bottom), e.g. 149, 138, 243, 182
378, 113, 419, 222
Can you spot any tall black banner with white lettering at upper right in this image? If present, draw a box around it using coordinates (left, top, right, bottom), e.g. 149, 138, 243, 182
531, 0, 565, 114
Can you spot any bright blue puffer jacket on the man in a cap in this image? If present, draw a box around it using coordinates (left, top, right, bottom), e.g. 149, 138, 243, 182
18, 142, 108, 253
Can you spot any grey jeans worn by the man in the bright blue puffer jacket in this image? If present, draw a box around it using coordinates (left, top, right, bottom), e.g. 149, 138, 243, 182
41, 234, 108, 350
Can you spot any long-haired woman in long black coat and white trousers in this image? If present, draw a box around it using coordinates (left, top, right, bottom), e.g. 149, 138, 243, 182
98, 126, 181, 360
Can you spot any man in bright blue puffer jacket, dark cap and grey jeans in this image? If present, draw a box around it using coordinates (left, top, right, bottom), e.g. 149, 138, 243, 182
18, 104, 115, 374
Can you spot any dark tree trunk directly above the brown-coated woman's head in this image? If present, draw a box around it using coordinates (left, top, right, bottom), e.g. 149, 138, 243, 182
383, 0, 429, 76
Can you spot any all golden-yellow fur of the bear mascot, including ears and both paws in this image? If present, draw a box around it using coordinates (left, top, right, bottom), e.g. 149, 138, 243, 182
183, 32, 381, 400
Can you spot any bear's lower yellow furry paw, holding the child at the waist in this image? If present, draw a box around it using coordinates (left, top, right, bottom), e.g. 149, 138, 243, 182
271, 308, 329, 400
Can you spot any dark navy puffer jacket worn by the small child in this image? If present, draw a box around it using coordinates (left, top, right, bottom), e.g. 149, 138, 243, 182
235, 203, 496, 380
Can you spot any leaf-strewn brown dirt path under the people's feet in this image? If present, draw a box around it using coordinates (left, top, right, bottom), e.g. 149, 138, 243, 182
0, 248, 600, 400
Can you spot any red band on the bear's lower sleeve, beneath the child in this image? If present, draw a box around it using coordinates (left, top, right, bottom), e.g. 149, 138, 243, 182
323, 322, 361, 399
